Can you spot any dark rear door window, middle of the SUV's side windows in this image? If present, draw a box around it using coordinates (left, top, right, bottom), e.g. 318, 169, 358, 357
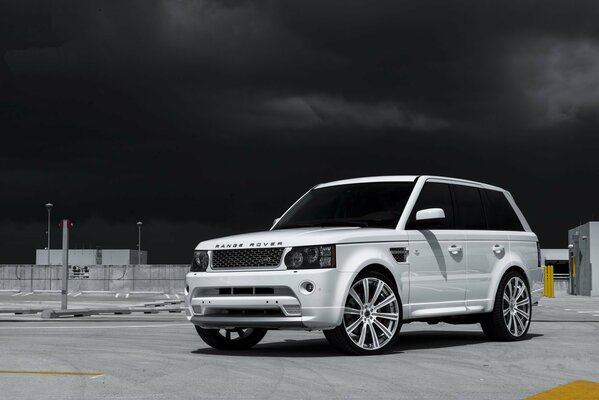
452, 185, 487, 229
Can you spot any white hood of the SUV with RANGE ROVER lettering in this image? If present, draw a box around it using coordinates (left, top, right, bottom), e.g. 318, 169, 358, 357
196, 227, 408, 250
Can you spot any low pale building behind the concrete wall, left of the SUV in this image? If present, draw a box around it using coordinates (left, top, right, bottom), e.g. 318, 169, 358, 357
35, 249, 148, 265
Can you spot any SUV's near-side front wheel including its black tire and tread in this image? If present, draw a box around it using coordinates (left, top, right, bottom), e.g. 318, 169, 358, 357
324, 271, 402, 355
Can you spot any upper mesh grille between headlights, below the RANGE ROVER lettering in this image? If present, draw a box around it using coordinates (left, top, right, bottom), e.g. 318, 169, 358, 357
212, 247, 285, 269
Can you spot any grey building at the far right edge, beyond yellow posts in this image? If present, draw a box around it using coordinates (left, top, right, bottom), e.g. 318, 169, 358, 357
568, 221, 599, 297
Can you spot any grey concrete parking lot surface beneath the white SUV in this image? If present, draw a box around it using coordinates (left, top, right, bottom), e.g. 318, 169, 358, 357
0, 294, 599, 400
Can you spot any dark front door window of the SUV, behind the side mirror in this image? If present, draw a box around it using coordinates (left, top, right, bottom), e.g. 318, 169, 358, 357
406, 183, 453, 229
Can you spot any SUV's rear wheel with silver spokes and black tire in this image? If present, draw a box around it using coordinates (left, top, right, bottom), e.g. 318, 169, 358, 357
480, 271, 532, 342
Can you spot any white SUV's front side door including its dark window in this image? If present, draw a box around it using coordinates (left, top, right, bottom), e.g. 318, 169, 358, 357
406, 181, 467, 318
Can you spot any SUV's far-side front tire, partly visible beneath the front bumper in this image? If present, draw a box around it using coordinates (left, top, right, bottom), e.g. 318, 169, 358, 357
196, 325, 268, 350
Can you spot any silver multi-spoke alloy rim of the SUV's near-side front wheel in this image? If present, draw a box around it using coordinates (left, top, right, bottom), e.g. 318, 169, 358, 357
343, 277, 399, 350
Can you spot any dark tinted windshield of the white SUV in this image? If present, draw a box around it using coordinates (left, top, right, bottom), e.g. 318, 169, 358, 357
274, 182, 414, 229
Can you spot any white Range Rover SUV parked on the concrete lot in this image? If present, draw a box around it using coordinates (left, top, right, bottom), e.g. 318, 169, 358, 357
186, 176, 543, 354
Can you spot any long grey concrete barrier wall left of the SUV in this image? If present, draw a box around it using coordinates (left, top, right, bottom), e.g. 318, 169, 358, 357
0, 264, 189, 294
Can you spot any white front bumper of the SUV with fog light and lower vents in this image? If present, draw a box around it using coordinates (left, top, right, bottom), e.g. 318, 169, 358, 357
185, 269, 352, 330
